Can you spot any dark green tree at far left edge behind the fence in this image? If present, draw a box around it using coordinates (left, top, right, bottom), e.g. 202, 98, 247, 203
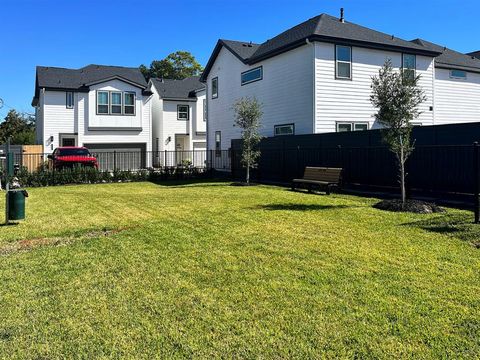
0, 110, 35, 145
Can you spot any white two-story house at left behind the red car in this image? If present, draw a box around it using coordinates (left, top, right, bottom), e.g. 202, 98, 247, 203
32, 65, 152, 162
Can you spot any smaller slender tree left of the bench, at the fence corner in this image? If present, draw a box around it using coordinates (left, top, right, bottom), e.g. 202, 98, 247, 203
233, 97, 263, 185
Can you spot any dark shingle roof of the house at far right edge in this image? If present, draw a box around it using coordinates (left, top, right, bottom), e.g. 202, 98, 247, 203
412, 39, 480, 72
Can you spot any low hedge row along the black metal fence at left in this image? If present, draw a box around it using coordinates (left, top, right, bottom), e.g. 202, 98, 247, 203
2, 167, 207, 187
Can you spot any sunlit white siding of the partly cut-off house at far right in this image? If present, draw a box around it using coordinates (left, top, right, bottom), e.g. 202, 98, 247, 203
435, 68, 480, 125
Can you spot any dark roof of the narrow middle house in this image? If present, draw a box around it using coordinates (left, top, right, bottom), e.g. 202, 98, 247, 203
150, 76, 205, 100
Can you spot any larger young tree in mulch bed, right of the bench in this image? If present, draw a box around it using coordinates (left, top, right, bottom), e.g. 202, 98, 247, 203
370, 60, 426, 207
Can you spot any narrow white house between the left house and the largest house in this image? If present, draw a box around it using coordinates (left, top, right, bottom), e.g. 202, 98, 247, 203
149, 76, 207, 152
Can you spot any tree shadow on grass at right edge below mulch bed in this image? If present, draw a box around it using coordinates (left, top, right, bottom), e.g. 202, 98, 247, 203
402, 214, 480, 248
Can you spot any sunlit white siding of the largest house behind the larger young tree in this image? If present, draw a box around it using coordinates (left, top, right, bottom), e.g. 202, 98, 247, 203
315, 42, 434, 133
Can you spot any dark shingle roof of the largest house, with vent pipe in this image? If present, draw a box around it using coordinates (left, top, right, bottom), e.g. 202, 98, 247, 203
201, 14, 439, 81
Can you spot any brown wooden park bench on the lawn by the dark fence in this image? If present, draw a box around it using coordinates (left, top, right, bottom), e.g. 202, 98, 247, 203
292, 166, 342, 195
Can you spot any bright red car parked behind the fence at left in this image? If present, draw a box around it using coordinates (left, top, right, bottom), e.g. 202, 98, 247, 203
48, 146, 98, 169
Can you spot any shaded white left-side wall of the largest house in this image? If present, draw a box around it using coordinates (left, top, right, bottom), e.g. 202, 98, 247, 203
207, 45, 313, 149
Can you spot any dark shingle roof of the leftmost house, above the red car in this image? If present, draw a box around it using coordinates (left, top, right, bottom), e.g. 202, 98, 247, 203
32, 64, 147, 105
